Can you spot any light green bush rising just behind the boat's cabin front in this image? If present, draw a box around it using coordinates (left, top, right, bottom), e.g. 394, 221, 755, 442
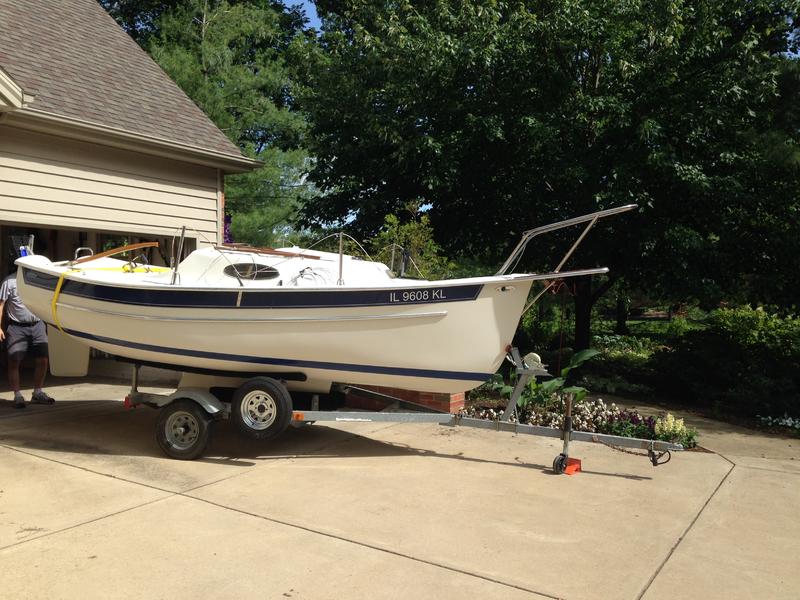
370, 203, 454, 279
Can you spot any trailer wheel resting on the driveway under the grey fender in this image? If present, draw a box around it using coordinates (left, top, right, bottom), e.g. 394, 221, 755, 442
156, 398, 211, 460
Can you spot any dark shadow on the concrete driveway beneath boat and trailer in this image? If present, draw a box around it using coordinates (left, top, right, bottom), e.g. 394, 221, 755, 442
0, 400, 650, 480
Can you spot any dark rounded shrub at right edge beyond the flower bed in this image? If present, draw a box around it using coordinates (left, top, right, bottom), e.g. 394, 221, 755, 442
653, 307, 800, 417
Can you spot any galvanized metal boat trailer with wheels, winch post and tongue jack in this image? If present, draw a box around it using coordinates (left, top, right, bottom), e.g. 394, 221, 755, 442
125, 348, 683, 474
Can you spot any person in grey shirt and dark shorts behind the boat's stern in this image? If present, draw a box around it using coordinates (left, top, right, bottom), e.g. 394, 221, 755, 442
0, 272, 55, 408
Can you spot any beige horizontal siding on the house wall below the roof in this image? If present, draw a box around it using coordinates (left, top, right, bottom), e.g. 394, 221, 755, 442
0, 125, 219, 245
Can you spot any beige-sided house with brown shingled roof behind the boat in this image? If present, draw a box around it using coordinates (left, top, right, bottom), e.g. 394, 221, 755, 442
0, 0, 258, 275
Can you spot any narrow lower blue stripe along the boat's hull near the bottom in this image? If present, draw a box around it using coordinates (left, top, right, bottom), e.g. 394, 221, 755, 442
51, 325, 492, 381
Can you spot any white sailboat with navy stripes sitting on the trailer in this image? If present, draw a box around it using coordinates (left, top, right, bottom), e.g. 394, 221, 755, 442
17, 205, 636, 393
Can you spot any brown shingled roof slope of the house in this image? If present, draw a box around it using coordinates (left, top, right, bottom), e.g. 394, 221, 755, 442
0, 0, 241, 157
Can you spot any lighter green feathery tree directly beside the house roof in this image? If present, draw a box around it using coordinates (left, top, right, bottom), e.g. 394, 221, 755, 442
106, 0, 314, 245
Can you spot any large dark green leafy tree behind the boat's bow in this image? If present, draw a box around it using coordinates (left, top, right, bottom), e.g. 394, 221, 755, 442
301, 0, 798, 348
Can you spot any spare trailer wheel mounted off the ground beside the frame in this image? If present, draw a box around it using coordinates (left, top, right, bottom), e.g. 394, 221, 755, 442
231, 377, 292, 440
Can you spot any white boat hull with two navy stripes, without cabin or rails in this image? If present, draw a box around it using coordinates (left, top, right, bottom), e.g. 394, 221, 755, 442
18, 257, 534, 393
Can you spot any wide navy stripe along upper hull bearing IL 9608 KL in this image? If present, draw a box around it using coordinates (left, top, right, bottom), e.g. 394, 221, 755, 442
23, 267, 483, 309
